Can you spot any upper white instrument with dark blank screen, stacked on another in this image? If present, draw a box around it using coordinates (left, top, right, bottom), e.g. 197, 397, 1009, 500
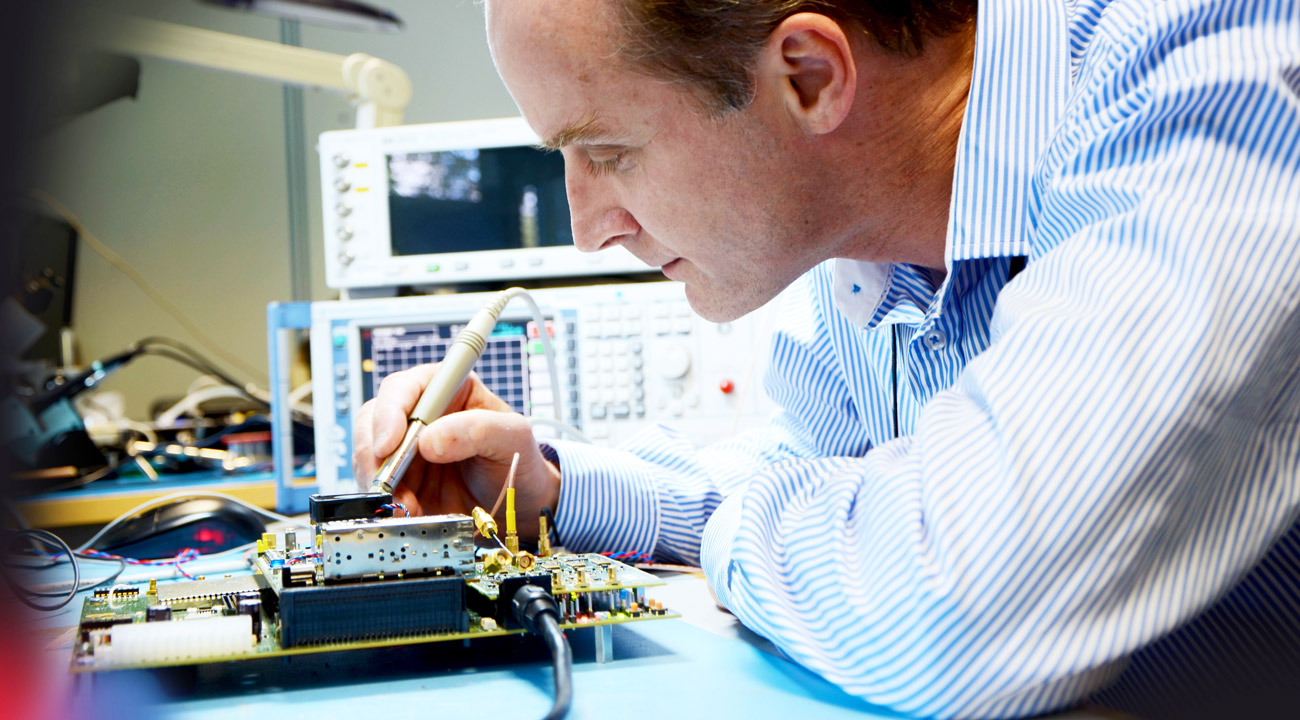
319, 118, 649, 290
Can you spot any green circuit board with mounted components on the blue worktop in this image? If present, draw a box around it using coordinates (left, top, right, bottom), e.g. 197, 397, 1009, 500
72, 495, 679, 672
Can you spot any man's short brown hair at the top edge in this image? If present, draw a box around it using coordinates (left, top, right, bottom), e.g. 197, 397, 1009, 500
616, 0, 978, 114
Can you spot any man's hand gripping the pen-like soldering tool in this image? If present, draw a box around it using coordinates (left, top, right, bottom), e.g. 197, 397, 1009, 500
352, 364, 560, 535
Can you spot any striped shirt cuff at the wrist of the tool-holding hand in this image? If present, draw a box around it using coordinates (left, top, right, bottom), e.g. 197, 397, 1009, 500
547, 441, 659, 554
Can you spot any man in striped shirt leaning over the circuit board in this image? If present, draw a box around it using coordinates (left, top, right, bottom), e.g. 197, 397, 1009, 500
356, 0, 1300, 717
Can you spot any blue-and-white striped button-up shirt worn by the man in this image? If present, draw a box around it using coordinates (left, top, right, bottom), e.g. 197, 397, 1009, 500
555, 0, 1300, 717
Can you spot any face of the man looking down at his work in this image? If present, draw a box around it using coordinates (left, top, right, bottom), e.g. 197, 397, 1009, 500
488, 0, 823, 322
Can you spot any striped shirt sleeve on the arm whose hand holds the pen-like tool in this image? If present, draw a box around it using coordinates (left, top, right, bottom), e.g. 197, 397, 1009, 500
547, 266, 871, 565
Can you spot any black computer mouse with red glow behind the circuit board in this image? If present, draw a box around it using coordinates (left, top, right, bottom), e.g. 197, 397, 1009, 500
92, 498, 267, 559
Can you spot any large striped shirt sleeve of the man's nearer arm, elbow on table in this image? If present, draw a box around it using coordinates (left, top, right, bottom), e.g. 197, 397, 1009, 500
562, 5, 1300, 717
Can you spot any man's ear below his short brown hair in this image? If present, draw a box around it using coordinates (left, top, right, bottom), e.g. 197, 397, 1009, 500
757, 13, 858, 135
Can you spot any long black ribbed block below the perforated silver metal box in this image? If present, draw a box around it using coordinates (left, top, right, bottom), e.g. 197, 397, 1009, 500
280, 576, 467, 647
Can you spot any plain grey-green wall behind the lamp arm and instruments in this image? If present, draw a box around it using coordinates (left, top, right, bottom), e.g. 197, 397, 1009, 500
36, 0, 516, 417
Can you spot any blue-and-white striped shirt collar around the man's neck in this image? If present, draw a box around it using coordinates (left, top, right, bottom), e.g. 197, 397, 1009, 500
832, 0, 1070, 329
